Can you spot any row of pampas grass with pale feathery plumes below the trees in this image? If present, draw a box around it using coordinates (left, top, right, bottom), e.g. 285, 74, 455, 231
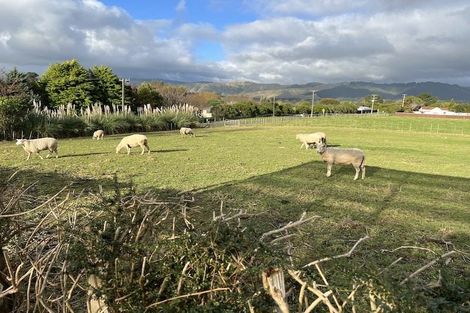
11, 102, 199, 138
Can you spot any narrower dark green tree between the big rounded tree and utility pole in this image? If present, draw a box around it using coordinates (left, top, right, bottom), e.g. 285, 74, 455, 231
90, 65, 121, 105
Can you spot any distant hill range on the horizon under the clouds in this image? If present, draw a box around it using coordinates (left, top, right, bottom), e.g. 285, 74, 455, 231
129, 80, 470, 102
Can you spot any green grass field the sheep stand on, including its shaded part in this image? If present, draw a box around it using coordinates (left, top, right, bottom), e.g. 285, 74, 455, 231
0, 114, 470, 312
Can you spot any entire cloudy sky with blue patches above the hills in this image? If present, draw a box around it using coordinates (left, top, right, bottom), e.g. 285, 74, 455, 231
0, 0, 470, 86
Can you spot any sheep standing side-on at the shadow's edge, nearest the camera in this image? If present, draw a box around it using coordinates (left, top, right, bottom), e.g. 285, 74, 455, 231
317, 143, 366, 180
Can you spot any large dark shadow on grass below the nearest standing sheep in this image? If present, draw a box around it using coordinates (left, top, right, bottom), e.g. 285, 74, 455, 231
191, 161, 470, 262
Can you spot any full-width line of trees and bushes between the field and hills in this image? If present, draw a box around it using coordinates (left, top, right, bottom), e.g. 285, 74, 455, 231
0, 59, 470, 139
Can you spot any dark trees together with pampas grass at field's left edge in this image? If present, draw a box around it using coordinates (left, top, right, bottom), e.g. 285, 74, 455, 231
0, 60, 218, 139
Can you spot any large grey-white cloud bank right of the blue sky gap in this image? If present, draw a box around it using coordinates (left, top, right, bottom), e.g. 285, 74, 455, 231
218, 1, 470, 85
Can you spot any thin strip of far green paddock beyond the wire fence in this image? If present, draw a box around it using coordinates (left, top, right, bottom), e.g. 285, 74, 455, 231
209, 114, 470, 136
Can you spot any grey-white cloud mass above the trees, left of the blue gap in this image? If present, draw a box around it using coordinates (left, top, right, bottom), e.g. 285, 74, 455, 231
0, 0, 223, 80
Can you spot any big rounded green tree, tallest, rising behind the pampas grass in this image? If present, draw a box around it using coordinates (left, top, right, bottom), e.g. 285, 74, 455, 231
40, 59, 95, 108
